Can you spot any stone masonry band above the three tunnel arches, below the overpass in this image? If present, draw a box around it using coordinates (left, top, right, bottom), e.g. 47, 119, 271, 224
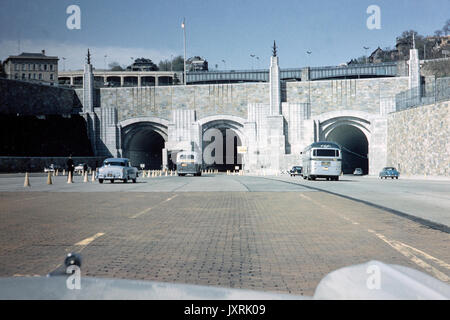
76, 77, 408, 121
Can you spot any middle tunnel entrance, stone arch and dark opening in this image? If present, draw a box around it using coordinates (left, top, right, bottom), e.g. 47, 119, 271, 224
199, 115, 246, 171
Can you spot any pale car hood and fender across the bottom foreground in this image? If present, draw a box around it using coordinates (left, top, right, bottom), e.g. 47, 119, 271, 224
0, 261, 450, 300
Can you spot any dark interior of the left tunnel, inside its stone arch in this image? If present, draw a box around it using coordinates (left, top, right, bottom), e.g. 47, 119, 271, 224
124, 127, 164, 170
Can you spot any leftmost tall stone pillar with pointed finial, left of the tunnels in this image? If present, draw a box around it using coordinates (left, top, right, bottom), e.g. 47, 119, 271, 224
83, 49, 97, 155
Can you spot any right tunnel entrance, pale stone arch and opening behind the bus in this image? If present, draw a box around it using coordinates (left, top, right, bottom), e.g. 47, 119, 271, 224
319, 112, 371, 174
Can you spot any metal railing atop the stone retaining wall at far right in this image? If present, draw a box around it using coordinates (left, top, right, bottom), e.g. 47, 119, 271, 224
395, 77, 450, 111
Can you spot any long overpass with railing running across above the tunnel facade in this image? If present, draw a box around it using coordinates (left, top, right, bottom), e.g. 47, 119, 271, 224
58, 62, 403, 87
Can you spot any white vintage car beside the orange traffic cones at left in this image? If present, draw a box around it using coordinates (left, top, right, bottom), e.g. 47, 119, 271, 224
97, 158, 138, 183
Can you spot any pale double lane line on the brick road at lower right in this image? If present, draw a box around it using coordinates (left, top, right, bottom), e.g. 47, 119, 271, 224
367, 229, 450, 282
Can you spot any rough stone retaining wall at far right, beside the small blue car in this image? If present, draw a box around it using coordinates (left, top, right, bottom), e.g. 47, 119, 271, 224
387, 101, 450, 177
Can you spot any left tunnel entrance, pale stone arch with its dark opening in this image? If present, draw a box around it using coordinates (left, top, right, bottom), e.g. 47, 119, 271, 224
121, 117, 168, 170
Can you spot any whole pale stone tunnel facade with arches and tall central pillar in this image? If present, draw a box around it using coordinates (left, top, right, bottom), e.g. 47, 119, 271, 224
76, 53, 424, 174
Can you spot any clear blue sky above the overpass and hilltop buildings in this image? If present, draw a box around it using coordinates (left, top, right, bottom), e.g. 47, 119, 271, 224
0, 0, 450, 69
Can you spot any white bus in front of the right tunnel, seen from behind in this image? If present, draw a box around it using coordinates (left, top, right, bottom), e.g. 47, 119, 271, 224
302, 141, 342, 181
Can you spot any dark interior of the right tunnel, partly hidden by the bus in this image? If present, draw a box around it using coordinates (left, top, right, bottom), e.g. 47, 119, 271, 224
326, 125, 369, 174
